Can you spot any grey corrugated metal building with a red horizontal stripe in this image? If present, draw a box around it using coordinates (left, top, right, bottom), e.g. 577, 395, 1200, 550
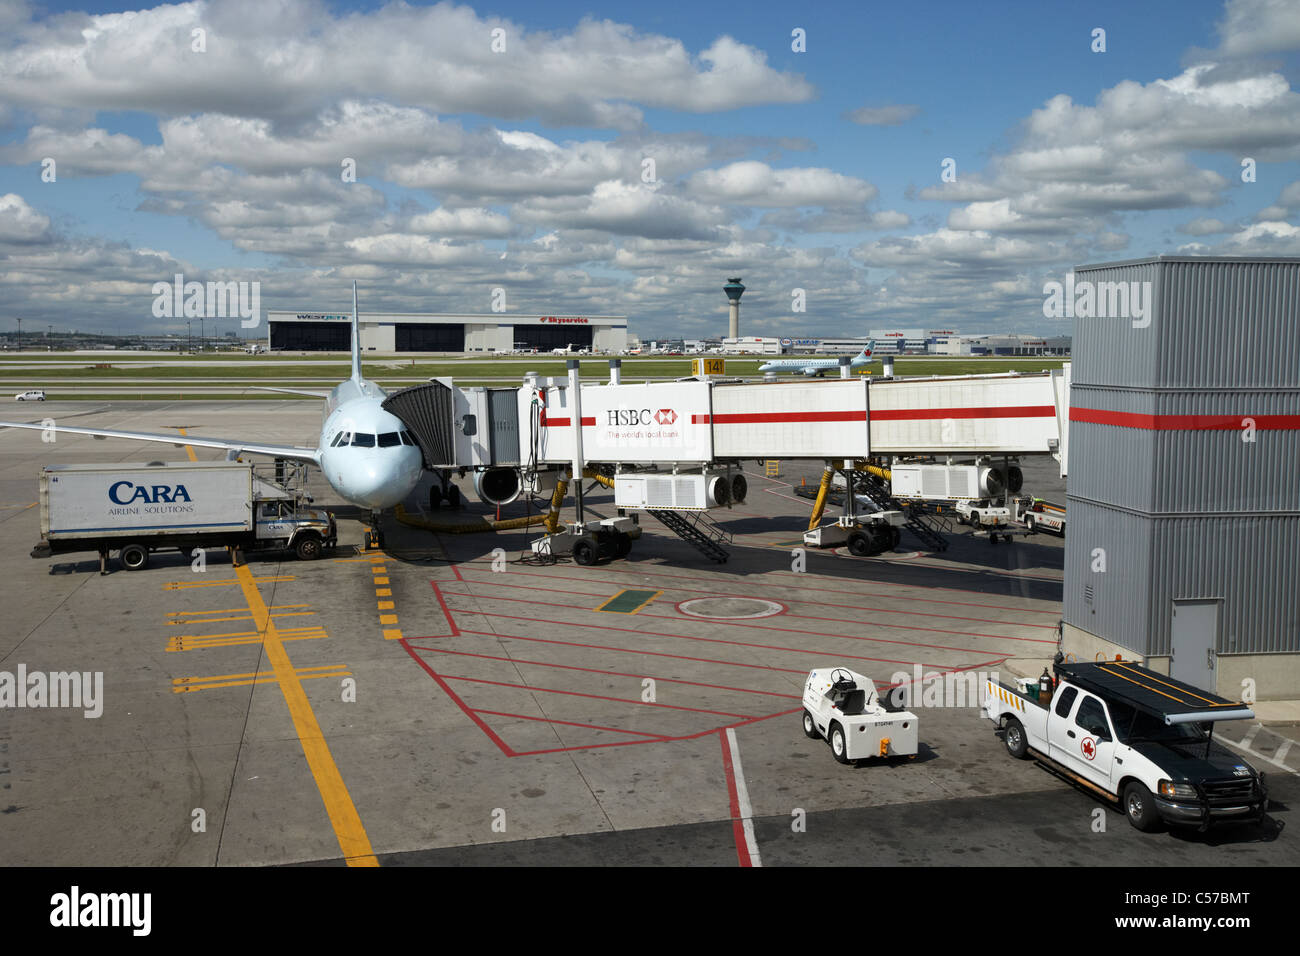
1065, 256, 1300, 700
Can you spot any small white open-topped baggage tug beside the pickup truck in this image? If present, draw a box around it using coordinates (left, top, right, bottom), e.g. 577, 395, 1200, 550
803, 667, 917, 763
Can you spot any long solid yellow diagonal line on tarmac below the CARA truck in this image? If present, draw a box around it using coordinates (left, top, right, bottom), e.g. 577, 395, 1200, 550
235, 567, 380, 866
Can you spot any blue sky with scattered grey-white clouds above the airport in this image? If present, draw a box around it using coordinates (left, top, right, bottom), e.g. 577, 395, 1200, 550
0, 0, 1300, 337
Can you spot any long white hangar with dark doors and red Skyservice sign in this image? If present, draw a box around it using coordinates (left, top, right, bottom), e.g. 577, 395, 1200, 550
267, 311, 628, 352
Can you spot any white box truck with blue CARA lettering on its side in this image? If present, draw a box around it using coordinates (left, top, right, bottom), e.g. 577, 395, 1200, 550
31, 462, 338, 574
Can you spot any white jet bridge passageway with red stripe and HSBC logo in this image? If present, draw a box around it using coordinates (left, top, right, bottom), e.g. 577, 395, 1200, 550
519, 368, 1069, 475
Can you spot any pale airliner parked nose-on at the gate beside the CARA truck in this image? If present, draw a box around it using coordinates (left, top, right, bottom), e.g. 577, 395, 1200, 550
0, 282, 424, 544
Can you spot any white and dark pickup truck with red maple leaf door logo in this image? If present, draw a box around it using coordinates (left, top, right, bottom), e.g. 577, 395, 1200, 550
980, 654, 1269, 830
